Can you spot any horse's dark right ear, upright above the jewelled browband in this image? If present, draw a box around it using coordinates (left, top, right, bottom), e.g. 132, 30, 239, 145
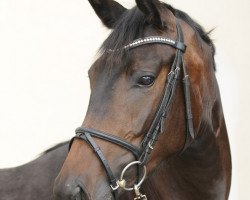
136, 0, 165, 30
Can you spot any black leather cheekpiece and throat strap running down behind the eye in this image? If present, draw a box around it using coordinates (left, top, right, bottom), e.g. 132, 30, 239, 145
140, 19, 193, 164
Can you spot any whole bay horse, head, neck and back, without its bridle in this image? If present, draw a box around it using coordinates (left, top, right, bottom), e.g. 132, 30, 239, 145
0, 0, 231, 200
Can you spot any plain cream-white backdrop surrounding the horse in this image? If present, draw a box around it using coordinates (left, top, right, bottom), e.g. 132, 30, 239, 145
0, 0, 250, 200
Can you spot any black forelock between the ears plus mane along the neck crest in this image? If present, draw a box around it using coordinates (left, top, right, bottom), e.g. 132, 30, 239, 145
100, 3, 215, 69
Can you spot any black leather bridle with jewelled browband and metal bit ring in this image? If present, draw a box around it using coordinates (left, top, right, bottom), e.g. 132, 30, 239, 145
69, 18, 194, 200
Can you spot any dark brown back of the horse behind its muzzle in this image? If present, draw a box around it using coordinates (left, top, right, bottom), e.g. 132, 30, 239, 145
0, 142, 69, 200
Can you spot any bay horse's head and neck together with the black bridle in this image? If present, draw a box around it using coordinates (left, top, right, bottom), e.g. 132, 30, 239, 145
53, 0, 231, 200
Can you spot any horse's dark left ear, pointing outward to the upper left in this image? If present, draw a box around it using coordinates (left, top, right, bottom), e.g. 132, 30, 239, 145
89, 0, 127, 28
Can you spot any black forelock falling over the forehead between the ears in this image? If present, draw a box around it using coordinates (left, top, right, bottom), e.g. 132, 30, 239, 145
99, 7, 146, 69
